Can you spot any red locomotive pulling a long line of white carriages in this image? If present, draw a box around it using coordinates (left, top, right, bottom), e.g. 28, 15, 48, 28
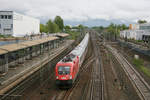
55, 33, 89, 86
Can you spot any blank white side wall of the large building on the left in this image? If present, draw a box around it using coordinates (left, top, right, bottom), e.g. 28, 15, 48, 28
13, 12, 40, 36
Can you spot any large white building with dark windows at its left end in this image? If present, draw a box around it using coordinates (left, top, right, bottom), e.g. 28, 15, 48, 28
0, 11, 40, 37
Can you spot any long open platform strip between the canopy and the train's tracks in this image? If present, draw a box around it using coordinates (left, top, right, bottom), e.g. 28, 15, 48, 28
0, 40, 74, 94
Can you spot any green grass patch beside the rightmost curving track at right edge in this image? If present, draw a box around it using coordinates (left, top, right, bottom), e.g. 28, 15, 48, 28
133, 59, 150, 77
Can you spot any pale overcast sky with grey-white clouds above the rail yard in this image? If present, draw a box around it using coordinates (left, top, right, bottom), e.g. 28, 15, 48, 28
0, 0, 150, 25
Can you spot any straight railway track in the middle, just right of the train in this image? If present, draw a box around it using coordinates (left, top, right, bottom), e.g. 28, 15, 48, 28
90, 33, 104, 100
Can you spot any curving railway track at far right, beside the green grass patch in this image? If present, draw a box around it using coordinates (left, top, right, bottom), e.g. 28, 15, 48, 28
106, 45, 150, 100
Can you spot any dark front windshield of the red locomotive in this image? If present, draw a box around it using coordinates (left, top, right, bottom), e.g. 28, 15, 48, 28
58, 66, 70, 75
